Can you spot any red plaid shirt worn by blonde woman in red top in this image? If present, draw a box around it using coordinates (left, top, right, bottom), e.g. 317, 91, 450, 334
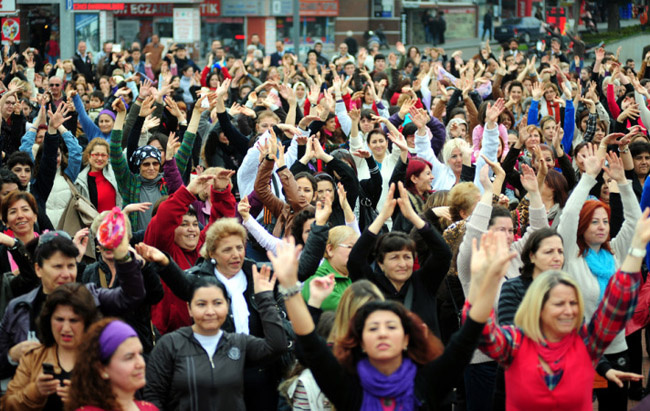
463, 270, 641, 389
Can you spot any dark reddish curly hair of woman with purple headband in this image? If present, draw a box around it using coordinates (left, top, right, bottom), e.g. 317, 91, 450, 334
65, 318, 122, 411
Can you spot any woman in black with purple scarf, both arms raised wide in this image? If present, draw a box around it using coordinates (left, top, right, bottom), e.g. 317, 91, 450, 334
269, 230, 510, 410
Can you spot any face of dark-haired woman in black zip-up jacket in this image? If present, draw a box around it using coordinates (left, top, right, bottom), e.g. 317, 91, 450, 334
189, 286, 228, 335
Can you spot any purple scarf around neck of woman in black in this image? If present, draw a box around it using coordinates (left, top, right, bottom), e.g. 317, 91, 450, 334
357, 357, 417, 411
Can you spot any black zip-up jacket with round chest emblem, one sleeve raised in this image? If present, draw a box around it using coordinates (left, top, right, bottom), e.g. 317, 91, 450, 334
144, 291, 287, 411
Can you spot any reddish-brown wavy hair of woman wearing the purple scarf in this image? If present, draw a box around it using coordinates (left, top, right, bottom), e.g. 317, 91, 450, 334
334, 301, 444, 374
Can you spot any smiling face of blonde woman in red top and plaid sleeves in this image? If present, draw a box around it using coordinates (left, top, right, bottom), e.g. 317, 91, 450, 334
540, 284, 582, 342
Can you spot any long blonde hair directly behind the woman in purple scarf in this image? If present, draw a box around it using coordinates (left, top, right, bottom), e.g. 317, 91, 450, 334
327, 280, 384, 343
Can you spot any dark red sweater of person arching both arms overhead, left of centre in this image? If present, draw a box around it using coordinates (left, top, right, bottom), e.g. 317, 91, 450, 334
144, 186, 237, 334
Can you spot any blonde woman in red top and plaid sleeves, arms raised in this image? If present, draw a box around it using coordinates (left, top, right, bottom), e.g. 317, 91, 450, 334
465, 210, 650, 411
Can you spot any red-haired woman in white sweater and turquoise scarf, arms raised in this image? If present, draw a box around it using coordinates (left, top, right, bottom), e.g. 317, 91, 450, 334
558, 145, 645, 410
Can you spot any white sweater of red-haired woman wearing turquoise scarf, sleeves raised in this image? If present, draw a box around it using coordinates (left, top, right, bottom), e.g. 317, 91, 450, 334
557, 174, 641, 354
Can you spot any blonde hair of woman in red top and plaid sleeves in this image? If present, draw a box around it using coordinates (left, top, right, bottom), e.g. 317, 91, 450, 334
515, 270, 585, 343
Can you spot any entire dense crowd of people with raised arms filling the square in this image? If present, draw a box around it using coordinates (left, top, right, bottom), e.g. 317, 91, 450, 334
0, 24, 650, 411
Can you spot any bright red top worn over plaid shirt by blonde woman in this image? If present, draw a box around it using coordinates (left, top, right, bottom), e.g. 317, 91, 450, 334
505, 333, 595, 411
